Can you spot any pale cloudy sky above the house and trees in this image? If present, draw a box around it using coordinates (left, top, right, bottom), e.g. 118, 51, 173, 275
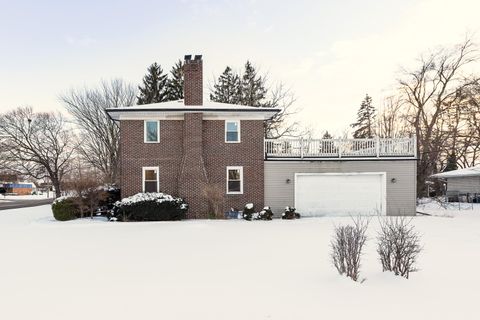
0, 0, 480, 135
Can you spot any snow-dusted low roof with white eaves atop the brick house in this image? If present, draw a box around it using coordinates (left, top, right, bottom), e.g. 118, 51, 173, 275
106, 100, 281, 120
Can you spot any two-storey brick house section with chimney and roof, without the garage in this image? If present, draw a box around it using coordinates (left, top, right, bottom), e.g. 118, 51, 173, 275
108, 56, 279, 218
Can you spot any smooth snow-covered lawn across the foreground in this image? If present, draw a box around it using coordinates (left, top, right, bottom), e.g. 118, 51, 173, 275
0, 206, 480, 320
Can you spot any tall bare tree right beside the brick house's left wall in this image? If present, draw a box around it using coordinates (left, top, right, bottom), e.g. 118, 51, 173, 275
60, 79, 136, 184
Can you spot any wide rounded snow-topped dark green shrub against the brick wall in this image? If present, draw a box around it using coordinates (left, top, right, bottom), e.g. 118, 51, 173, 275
114, 192, 188, 221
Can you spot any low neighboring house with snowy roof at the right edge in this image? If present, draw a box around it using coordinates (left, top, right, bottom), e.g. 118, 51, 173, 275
431, 165, 480, 202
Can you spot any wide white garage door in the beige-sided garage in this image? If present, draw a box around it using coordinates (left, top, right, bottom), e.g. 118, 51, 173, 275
295, 172, 386, 216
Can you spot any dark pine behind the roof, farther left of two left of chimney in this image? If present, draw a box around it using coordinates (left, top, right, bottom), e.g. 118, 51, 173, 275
137, 62, 168, 104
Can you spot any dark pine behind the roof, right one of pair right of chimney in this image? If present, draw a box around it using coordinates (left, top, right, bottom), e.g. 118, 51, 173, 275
240, 61, 268, 107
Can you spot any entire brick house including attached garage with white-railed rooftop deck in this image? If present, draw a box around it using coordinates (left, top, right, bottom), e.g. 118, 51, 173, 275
107, 56, 416, 218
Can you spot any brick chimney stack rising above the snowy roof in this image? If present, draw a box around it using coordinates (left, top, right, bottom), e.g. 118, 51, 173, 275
183, 55, 203, 106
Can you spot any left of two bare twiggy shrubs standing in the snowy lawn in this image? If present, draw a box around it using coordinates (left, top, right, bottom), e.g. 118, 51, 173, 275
331, 216, 369, 281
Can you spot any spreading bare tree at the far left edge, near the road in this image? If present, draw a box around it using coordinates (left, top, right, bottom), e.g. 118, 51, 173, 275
0, 107, 76, 197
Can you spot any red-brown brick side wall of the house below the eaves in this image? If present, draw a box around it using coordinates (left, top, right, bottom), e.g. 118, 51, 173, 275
120, 117, 264, 218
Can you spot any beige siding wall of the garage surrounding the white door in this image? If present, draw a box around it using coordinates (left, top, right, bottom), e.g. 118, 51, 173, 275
264, 160, 416, 215
